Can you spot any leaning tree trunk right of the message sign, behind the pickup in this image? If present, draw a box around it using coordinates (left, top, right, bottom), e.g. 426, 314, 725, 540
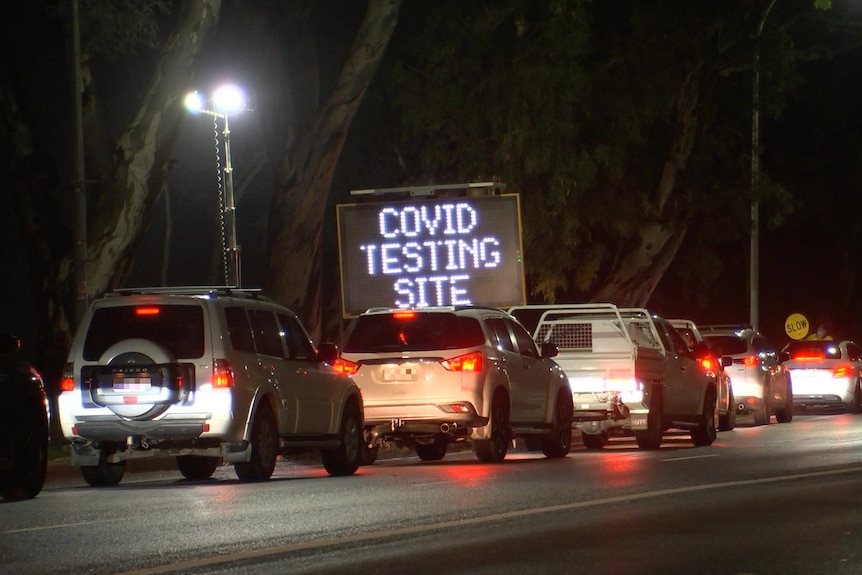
592, 69, 700, 307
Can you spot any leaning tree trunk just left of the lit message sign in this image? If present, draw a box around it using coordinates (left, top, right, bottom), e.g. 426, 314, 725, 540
267, 0, 401, 339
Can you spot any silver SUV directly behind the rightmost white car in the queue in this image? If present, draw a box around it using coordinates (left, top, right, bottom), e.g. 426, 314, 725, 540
699, 325, 793, 425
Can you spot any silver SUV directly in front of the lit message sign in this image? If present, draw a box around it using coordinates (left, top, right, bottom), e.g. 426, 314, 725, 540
338, 307, 573, 462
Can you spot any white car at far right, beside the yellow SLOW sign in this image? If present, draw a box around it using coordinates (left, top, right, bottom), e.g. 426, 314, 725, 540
782, 340, 862, 413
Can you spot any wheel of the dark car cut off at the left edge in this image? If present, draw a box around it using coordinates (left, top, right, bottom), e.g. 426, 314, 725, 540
0, 404, 48, 501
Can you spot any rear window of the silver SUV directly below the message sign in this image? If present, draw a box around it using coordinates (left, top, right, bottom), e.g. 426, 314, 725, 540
344, 312, 492, 353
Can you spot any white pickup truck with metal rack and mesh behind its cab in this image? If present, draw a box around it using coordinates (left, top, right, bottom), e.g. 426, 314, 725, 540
509, 303, 718, 449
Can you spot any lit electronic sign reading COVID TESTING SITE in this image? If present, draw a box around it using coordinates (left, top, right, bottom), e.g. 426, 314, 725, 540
337, 194, 525, 317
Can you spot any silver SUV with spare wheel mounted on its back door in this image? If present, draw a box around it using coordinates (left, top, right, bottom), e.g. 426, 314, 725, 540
58, 288, 363, 486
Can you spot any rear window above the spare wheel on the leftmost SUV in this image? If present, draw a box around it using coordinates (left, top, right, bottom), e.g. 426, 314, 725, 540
84, 305, 204, 361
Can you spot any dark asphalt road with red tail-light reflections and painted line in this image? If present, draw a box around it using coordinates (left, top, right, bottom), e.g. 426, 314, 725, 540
0, 414, 862, 575
